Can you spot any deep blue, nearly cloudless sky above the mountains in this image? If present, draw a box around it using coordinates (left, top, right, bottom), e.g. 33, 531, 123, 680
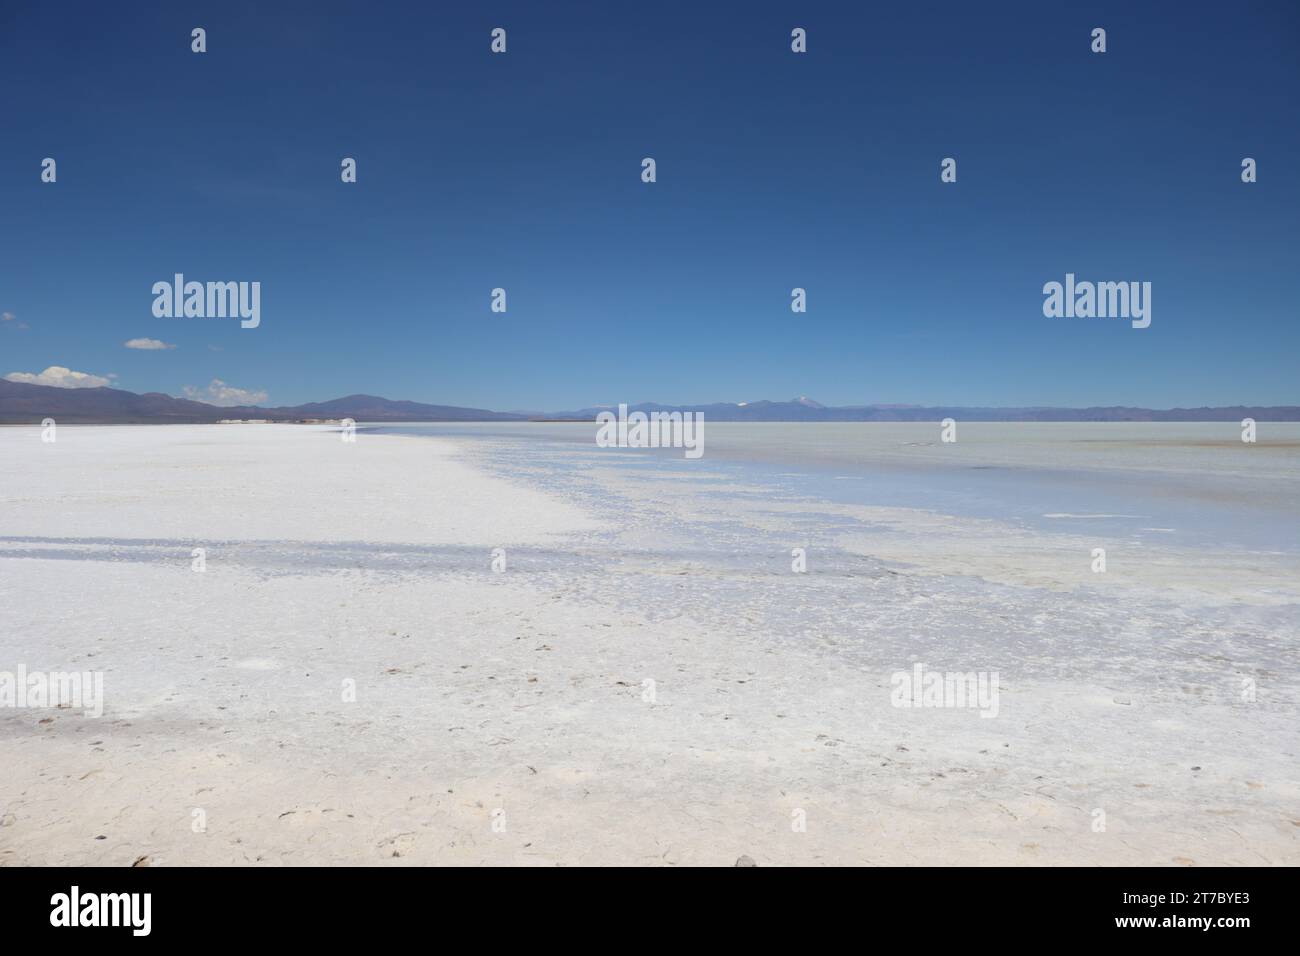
0, 0, 1300, 410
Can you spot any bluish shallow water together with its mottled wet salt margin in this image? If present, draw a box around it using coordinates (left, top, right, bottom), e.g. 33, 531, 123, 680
353, 424, 1300, 706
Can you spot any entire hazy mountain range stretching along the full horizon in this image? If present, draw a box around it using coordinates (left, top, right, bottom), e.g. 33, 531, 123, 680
0, 378, 1300, 424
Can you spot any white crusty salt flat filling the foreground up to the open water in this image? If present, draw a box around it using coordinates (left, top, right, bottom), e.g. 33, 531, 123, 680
0, 425, 1300, 865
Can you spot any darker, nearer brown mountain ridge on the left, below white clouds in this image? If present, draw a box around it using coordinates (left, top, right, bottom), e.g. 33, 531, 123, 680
0, 378, 527, 424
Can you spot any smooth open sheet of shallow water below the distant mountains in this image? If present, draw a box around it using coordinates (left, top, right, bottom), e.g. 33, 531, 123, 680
373, 421, 1300, 553
